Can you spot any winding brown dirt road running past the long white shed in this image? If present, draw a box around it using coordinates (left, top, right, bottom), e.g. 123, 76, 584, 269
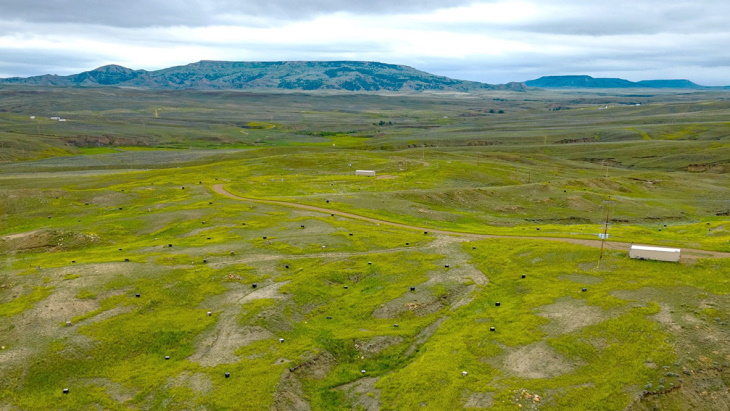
213, 184, 730, 259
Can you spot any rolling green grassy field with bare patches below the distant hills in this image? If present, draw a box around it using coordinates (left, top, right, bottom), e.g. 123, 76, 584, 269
0, 87, 730, 410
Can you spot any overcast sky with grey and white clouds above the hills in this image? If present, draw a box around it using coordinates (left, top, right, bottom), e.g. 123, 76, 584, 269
0, 0, 730, 85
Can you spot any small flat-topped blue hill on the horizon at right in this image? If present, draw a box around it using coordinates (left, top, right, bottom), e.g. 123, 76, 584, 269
525, 76, 712, 89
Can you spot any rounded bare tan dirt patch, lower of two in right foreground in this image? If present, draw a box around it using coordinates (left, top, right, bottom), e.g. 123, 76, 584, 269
502, 342, 574, 379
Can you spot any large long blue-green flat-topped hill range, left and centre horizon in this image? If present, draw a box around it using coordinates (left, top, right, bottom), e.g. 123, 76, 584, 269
0, 61, 524, 91
